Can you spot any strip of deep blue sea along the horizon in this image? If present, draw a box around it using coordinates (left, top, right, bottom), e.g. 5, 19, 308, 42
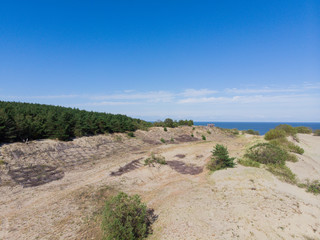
194, 122, 320, 135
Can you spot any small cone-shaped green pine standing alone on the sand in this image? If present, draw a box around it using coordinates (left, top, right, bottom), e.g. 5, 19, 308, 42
208, 144, 235, 171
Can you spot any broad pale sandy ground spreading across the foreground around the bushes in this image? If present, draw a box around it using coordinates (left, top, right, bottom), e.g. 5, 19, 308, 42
0, 128, 320, 240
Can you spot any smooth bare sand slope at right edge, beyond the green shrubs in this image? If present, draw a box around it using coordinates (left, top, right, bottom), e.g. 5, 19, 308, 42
288, 134, 320, 181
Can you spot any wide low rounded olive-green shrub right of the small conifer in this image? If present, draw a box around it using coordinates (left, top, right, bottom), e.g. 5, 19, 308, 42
244, 143, 289, 165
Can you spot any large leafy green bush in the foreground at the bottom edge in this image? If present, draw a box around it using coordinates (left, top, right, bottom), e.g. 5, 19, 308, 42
102, 192, 148, 240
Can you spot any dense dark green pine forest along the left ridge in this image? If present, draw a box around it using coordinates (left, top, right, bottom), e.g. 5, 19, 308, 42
0, 101, 152, 142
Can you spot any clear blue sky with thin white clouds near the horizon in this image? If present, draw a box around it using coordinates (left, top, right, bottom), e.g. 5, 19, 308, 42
0, 0, 320, 122
